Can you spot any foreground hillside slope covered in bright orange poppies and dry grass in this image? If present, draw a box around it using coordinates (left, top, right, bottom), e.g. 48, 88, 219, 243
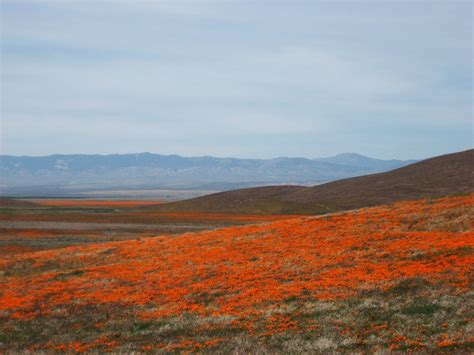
0, 195, 474, 353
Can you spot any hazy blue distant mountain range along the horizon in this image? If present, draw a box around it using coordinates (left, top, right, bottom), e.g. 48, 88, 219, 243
0, 153, 415, 195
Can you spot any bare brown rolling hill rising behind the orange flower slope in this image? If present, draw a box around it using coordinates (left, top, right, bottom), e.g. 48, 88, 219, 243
153, 149, 474, 214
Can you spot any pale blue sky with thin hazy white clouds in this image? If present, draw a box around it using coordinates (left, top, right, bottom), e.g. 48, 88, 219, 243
0, 0, 473, 159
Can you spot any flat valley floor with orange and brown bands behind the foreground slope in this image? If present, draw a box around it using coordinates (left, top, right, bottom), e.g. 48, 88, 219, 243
0, 199, 288, 256
